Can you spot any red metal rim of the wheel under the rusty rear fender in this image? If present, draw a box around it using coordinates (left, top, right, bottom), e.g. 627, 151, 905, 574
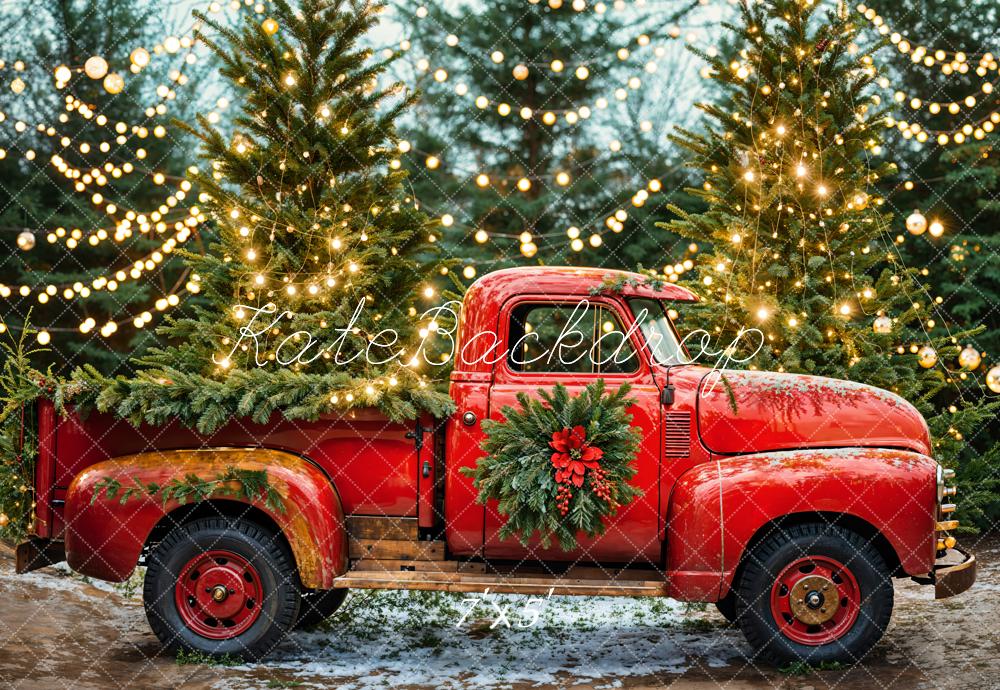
174, 551, 263, 640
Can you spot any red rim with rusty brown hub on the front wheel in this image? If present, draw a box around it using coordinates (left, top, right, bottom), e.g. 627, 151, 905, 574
771, 556, 861, 646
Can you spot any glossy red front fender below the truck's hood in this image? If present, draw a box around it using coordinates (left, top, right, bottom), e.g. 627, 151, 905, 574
667, 448, 937, 601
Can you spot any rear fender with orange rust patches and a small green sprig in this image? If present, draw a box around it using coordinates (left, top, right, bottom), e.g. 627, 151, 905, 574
65, 448, 347, 589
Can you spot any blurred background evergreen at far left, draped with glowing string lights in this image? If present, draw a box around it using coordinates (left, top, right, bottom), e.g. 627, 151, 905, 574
0, 0, 203, 372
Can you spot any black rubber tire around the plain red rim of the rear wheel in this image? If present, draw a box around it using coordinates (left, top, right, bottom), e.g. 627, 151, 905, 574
143, 517, 300, 660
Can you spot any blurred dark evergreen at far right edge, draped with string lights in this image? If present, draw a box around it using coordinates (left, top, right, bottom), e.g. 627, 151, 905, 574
854, 0, 1000, 527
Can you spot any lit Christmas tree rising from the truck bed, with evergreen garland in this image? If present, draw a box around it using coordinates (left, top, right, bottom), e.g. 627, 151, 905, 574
77, 0, 450, 431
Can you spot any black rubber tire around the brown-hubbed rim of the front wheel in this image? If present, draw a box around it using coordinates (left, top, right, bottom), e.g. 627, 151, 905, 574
735, 524, 893, 666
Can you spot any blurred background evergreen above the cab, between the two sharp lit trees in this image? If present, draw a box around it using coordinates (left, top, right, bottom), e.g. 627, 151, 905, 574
400, 2, 697, 278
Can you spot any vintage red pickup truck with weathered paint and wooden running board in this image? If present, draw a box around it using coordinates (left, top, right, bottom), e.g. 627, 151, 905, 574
17, 267, 976, 663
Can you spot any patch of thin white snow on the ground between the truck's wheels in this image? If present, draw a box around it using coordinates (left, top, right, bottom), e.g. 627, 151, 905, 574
218, 591, 745, 688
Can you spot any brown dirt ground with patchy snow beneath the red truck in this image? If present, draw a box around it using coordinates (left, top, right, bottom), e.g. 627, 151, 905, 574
0, 537, 1000, 690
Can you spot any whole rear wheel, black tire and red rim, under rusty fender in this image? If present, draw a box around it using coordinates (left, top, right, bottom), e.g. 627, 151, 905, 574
143, 517, 299, 659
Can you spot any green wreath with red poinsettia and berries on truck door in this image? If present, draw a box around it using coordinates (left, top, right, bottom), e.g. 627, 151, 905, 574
462, 379, 642, 551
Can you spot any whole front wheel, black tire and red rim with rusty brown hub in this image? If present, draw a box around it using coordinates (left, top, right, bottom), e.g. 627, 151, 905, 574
736, 524, 893, 665
